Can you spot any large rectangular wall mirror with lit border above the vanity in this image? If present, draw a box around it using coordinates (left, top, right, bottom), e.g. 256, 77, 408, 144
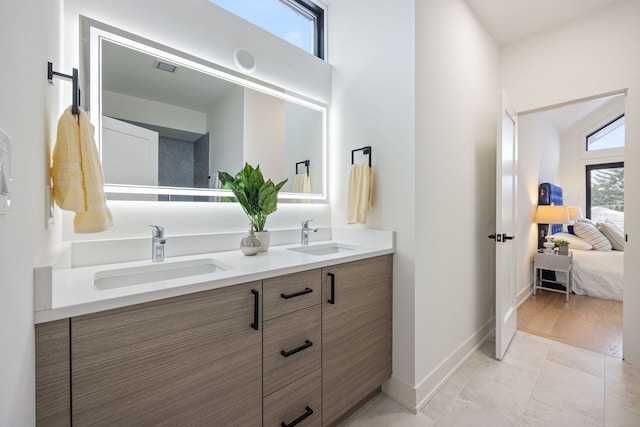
81, 17, 327, 201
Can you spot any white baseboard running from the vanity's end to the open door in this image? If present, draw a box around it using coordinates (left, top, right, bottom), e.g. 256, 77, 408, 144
382, 318, 495, 414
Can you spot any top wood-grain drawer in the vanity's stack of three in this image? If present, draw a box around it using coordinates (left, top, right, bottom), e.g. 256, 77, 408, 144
263, 269, 321, 320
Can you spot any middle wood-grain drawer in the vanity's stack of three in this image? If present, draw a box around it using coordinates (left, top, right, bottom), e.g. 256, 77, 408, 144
262, 305, 322, 396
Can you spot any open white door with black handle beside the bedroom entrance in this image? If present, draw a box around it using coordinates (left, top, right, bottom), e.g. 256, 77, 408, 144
495, 94, 518, 359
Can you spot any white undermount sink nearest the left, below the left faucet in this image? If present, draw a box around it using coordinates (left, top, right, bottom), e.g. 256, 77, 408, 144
93, 258, 226, 290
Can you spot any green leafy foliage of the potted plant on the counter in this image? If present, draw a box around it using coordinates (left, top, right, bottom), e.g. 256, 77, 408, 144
218, 163, 287, 231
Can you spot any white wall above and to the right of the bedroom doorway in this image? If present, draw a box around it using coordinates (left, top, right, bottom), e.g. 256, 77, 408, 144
500, 0, 640, 364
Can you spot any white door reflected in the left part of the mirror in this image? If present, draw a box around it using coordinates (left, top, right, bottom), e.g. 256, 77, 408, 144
100, 116, 158, 187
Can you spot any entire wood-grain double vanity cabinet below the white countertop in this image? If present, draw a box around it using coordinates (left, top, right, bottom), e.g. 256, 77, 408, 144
36, 255, 392, 427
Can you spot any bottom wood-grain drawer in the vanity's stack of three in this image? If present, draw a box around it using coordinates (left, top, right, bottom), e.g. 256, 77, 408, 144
263, 369, 322, 427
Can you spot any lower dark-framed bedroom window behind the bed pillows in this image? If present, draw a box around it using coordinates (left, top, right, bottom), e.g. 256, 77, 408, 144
586, 162, 624, 227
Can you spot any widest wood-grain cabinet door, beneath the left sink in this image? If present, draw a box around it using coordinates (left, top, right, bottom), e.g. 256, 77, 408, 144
71, 282, 262, 426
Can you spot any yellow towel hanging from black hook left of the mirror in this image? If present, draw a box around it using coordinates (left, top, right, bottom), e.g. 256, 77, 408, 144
51, 107, 113, 233
